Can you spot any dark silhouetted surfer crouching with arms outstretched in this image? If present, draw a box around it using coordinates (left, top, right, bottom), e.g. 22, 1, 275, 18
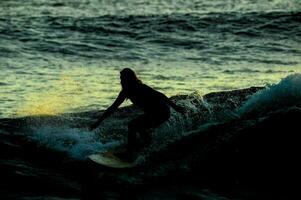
90, 68, 185, 160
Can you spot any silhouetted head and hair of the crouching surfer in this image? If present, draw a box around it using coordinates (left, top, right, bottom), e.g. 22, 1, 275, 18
120, 68, 141, 89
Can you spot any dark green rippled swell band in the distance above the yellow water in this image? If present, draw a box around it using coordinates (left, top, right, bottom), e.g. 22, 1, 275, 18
0, 12, 301, 60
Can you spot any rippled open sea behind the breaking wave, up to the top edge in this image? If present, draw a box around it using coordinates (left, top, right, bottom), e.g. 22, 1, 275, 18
0, 0, 301, 117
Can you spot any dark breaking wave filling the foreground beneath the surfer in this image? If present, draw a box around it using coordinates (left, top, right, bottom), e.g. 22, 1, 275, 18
0, 74, 301, 199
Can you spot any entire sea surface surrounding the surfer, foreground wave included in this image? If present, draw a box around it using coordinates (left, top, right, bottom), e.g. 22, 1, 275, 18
0, 0, 301, 199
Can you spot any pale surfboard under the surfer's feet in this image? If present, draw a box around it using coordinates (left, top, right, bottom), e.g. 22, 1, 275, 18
88, 151, 135, 168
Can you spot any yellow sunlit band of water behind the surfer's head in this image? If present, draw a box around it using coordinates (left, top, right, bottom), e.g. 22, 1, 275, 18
0, 63, 301, 117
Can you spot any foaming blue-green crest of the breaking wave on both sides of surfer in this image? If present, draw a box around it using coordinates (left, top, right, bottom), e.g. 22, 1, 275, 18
0, 74, 301, 160
